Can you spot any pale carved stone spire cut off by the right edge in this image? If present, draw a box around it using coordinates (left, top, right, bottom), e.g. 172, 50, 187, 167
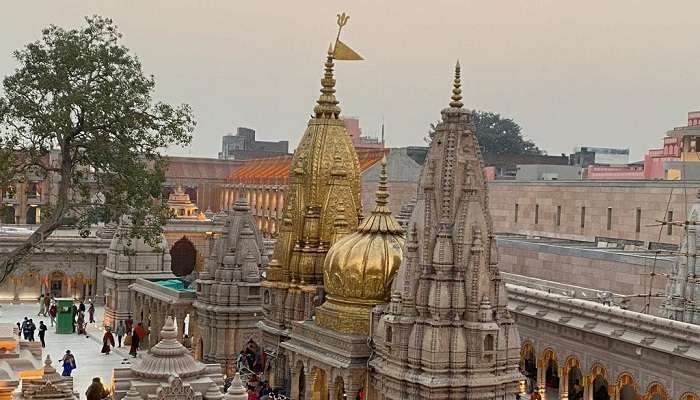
663, 191, 700, 325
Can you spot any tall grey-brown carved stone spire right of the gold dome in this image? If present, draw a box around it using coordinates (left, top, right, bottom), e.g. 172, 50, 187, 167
370, 64, 521, 399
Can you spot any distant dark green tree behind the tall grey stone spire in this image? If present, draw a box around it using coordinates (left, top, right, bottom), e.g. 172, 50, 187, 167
426, 111, 542, 157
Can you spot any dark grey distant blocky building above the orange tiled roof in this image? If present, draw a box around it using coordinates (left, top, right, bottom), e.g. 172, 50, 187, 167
219, 127, 289, 160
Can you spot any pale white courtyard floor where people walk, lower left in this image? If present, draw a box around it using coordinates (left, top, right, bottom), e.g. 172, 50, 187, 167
0, 304, 141, 398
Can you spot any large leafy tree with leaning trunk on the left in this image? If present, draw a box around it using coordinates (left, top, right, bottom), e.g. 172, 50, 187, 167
0, 16, 195, 283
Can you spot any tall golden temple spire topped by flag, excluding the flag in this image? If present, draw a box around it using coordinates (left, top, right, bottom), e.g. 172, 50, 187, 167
259, 46, 361, 386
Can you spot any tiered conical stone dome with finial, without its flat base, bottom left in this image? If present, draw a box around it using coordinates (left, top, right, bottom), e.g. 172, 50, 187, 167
131, 316, 206, 380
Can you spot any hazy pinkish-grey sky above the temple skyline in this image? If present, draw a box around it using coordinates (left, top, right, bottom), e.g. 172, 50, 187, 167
0, 0, 700, 159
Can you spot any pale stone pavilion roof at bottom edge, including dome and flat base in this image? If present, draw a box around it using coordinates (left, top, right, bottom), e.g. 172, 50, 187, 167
112, 316, 224, 400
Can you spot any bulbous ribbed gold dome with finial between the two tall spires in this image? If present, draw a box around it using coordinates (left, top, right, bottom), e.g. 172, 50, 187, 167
316, 159, 405, 334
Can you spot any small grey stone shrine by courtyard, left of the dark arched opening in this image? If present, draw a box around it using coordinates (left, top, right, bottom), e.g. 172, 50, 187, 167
102, 218, 175, 329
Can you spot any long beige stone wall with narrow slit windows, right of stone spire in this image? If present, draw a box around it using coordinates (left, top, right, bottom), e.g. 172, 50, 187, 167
489, 180, 700, 248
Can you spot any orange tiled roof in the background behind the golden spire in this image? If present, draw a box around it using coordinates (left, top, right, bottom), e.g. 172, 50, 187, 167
229, 149, 388, 185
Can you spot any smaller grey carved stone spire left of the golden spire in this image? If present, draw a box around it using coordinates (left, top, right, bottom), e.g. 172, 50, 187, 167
194, 199, 268, 370
